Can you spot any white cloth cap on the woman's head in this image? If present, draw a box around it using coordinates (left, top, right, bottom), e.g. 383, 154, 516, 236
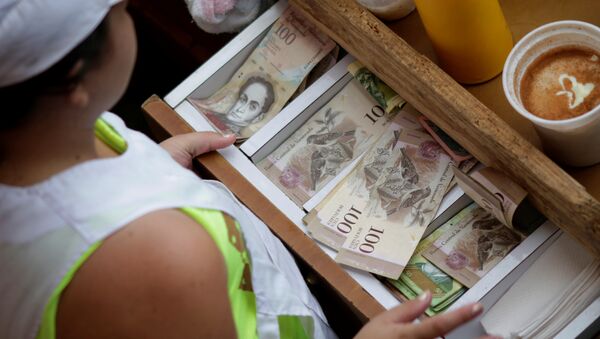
0, 0, 121, 87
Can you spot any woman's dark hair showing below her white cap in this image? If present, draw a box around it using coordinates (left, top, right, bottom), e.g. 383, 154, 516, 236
0, 18, 108, 130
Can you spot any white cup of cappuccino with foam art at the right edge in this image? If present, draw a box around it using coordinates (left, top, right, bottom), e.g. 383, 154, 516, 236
502, 21, 600, 166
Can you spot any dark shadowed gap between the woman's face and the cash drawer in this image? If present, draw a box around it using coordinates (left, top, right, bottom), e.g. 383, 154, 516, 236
112, 0, 235, 136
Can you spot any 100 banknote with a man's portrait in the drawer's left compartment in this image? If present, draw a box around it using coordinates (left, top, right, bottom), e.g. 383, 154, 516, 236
188, 7, 335, 141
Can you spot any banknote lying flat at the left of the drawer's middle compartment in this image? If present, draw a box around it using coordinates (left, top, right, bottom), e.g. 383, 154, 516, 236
257, 79, 394, 206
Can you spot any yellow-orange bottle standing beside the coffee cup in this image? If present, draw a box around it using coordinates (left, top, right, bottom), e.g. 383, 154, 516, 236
415, 0, 513, 84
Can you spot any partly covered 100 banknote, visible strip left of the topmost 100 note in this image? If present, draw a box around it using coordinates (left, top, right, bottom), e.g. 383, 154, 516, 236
305, 109, 419, 250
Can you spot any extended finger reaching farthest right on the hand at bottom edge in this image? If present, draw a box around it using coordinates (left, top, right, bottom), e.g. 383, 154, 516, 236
408, 303, 483, 338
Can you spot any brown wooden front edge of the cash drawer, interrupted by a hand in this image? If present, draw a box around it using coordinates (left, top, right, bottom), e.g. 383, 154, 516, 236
142, 96, 385, 323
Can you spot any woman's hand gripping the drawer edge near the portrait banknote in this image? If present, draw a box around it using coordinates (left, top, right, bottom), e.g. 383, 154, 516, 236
160, 132, 235, 169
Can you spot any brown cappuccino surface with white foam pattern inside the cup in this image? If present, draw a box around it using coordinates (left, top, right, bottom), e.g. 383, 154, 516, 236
520, 46, 600, 120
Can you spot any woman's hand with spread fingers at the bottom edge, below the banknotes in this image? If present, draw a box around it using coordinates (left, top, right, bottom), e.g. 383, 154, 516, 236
356, 292, 494, 339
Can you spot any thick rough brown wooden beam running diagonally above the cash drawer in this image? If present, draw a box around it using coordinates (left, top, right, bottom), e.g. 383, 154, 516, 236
290, 0, 600, 257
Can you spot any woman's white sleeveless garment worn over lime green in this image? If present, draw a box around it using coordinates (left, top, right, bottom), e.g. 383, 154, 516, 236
0, 113, 335, 339
